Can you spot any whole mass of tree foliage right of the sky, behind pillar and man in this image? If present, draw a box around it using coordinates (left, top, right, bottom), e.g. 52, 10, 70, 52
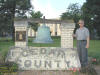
61, 0, 100, 39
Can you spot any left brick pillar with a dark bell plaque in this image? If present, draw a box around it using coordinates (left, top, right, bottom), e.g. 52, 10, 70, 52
14, 21, 28, 47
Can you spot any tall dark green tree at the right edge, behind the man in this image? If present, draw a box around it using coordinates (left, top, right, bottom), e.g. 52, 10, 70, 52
82, 0, 100, 36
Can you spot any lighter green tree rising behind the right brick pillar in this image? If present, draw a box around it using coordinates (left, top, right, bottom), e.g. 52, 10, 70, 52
61, 3, 81, 28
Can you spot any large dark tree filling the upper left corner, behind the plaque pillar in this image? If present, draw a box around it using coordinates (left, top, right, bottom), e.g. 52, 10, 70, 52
0, 0, 32, 39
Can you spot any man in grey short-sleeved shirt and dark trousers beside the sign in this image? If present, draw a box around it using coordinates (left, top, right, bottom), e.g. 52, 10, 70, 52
73, 20, 90, 67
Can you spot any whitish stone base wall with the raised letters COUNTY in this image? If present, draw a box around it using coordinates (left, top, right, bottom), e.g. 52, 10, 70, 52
6, 47, 81, 70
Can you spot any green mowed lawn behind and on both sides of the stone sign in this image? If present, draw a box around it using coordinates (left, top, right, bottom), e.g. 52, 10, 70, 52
0, 37, 100, 59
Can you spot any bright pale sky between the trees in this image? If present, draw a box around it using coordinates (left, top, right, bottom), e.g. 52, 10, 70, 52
31, 0, 86, 19
